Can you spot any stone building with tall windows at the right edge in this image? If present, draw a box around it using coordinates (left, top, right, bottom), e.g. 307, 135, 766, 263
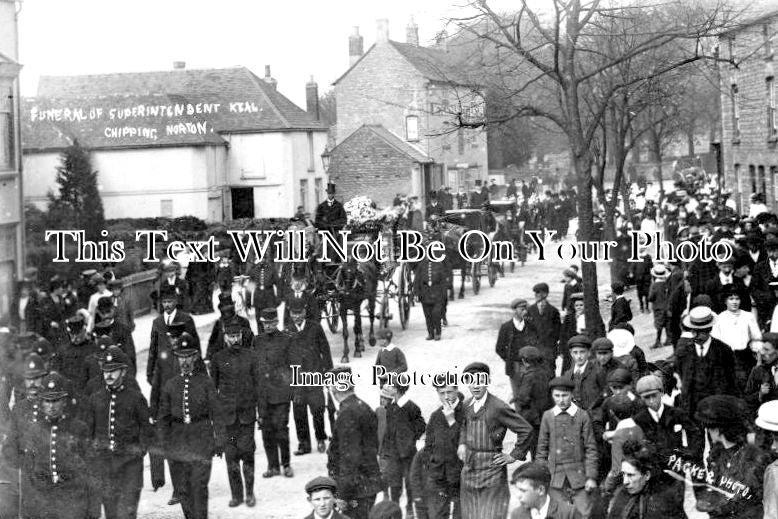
719, 10, 778, 212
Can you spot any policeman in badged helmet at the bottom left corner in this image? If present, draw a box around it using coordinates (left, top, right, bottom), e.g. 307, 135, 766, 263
3, 373, 100, 519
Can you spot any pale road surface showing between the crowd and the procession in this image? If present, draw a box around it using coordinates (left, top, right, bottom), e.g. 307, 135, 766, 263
126, 222, 705, 519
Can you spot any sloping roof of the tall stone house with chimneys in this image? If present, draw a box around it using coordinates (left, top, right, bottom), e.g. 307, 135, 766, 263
333, 40, 476, 85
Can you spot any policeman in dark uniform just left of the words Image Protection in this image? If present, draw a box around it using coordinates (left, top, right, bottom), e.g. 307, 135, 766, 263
254, 308, 294, 478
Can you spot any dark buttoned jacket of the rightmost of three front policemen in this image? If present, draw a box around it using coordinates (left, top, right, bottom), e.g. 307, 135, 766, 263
158, 369, 225, 462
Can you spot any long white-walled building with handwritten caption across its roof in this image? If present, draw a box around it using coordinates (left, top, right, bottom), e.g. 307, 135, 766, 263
22, 64, 327, 222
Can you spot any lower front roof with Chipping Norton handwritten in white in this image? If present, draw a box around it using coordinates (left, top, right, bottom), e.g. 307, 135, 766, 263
21, 95, 225, 151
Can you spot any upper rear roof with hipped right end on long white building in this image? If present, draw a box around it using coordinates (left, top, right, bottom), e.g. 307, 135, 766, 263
38, 67, 327, 133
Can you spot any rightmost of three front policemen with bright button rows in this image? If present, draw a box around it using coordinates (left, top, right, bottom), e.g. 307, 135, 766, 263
159, 341, 224, 519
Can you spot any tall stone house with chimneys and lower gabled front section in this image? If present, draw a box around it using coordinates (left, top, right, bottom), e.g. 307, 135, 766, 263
328, 20, 488, 206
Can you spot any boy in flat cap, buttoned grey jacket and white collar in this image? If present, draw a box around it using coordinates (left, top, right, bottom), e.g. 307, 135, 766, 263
535, 376, 598, 518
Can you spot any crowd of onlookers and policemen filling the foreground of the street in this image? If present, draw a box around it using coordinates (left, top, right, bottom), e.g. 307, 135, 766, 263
0, 173, 778, 519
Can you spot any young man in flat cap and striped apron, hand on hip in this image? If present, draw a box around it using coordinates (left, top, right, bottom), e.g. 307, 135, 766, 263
457, 362, 535, 519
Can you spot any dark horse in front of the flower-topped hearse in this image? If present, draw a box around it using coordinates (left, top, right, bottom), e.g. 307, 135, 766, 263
335, 257, 378, 363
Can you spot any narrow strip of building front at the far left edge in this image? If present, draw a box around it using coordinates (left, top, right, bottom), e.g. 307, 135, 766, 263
0, 0, 24, 325
